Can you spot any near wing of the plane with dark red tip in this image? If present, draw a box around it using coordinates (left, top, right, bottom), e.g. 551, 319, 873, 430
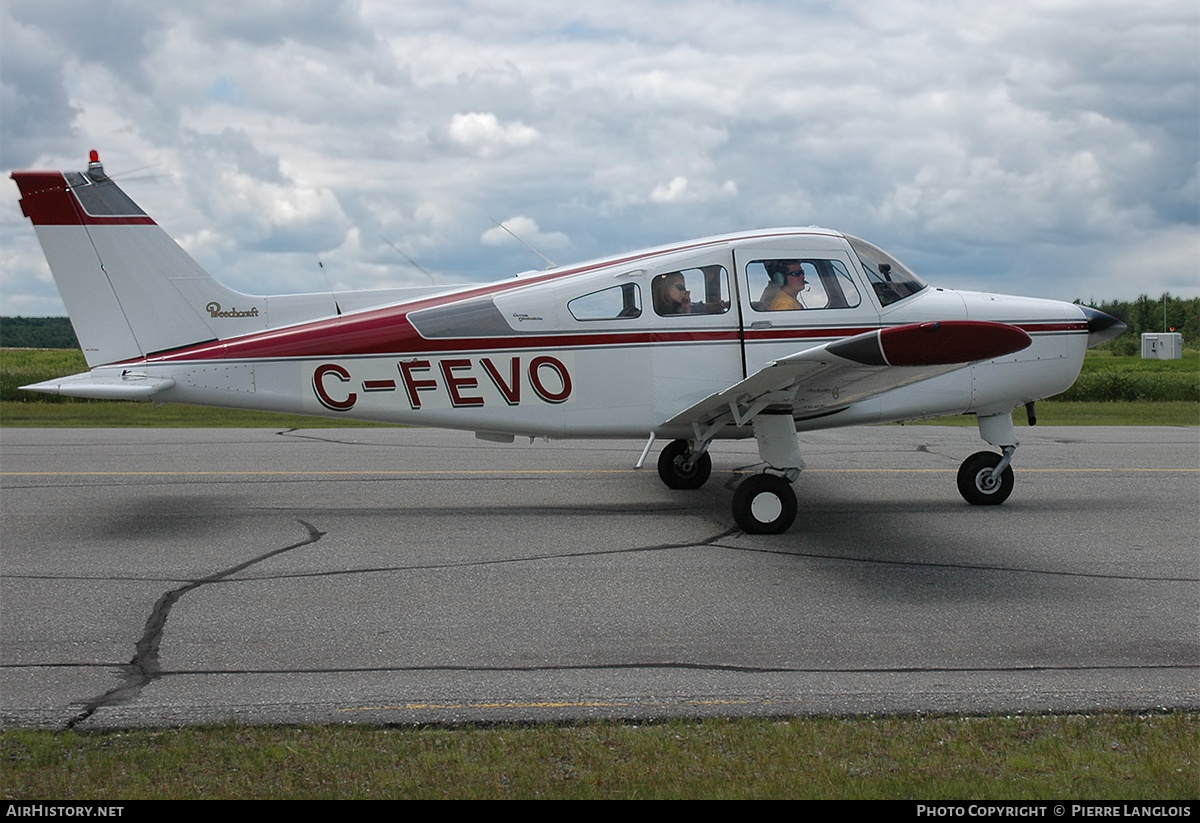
662, 320, 1032, 431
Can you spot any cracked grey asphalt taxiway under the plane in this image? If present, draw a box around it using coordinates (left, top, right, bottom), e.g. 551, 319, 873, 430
0, 426, 1200, 728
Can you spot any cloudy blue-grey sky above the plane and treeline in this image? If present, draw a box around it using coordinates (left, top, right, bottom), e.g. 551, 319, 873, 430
0, 0, 1200, 316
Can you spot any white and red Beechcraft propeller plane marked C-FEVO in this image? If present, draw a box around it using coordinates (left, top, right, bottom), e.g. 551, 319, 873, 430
12, 151, 1124, 534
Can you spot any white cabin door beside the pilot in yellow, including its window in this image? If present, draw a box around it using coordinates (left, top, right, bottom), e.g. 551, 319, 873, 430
733, 245, 880, 373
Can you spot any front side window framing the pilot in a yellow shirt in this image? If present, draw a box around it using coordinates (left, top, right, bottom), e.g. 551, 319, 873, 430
746, 258, 863, 312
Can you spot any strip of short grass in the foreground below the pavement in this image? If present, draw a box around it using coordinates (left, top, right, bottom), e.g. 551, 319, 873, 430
0, 713, 1200, 800
